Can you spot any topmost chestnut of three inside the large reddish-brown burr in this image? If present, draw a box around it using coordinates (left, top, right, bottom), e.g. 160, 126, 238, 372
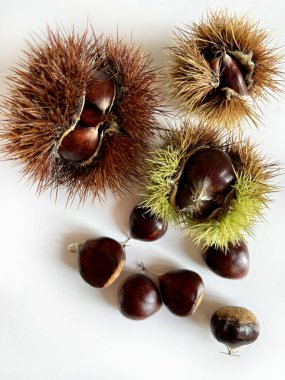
85, 71, 116, 113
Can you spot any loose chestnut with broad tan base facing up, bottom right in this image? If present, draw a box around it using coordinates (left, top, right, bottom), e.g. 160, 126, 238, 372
210, 306, 259, 355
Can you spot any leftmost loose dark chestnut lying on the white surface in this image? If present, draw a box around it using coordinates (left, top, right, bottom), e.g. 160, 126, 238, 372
78, 237, 126, 288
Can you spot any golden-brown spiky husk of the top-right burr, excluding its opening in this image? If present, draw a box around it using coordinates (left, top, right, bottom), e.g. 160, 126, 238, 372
169, 10, 284, 129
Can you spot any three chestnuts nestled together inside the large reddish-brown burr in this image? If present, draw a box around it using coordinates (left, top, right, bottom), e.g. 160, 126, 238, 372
57, 71, 119, 165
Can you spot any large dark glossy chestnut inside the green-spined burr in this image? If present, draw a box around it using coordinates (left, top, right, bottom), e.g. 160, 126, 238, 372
170, 147, 236, 220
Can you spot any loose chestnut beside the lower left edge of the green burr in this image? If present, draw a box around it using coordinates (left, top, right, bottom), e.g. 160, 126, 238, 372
129, 206, 167, 241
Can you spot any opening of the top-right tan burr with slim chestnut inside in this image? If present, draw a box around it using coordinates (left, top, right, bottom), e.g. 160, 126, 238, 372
206, 50, 254, 100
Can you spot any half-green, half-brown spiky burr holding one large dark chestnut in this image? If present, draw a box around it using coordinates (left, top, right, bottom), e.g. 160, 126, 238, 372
142, 121, 278, 251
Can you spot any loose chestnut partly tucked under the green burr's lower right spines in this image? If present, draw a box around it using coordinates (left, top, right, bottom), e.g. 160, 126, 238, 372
203, 241, 249, 279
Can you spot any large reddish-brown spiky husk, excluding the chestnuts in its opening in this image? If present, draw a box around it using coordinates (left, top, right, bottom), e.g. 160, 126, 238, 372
0, 29, 158, 201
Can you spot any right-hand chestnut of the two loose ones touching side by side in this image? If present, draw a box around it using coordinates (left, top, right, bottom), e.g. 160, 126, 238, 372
159, 269, 204, 317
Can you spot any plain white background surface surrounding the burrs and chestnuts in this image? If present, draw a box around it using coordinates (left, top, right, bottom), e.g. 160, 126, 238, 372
0, 0, 285, 380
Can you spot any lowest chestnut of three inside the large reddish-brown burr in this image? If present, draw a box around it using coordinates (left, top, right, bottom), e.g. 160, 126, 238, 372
58, 124, 101, 162
